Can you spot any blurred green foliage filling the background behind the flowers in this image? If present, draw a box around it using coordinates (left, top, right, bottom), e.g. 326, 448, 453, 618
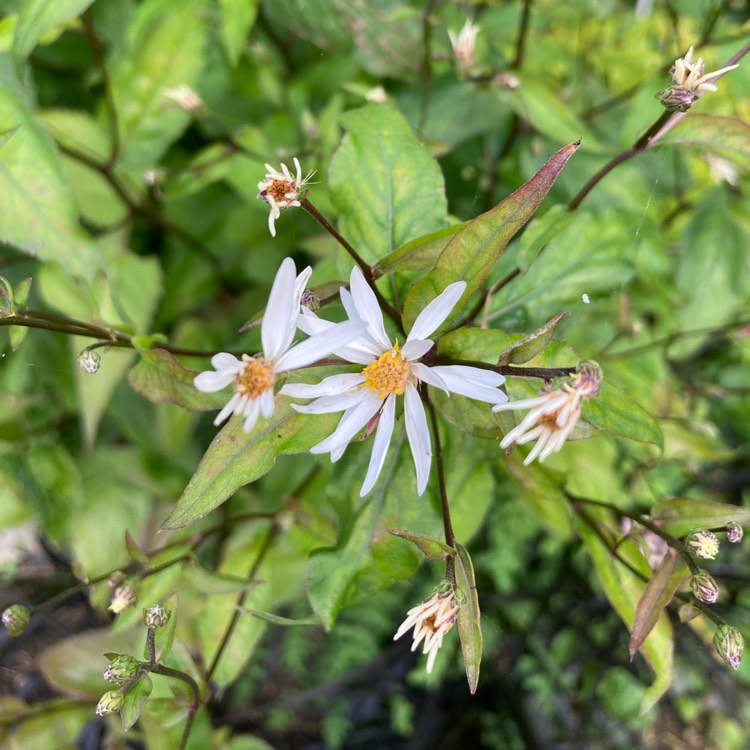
0, 0, 750, 750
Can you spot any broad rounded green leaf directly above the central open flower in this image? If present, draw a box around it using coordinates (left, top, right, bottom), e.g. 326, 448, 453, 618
329, 104, 448, 263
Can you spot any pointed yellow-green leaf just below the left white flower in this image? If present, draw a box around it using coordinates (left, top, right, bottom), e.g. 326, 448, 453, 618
162, 396, 338, 529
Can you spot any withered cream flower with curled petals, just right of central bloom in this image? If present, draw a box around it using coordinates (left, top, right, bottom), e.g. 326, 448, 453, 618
492, 362, 602, 466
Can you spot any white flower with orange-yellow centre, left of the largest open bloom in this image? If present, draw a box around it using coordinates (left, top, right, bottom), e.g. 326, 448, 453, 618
193, 258, 364, 432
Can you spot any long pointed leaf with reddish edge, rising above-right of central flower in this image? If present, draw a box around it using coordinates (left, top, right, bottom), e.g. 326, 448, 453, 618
404, 142, 579, 329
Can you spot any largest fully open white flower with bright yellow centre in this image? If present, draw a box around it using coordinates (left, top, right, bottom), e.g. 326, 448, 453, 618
281, 268, 507, 497
